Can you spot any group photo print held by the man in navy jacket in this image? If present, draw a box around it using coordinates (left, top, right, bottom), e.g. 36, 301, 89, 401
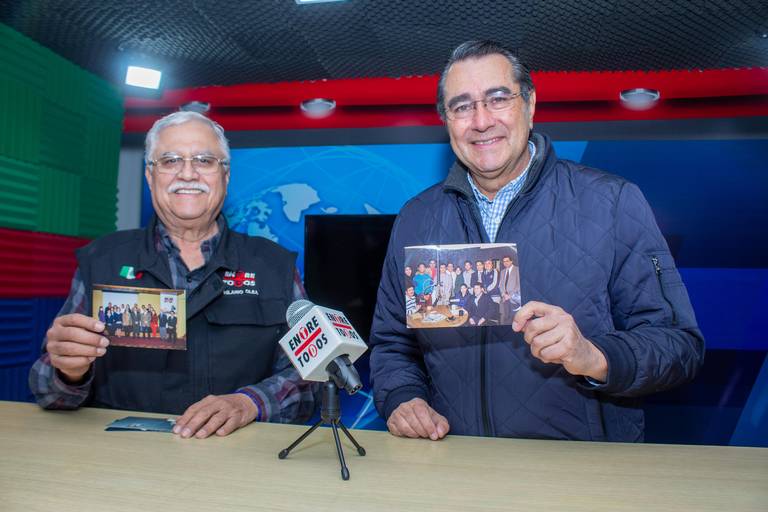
403, 244, 521, 329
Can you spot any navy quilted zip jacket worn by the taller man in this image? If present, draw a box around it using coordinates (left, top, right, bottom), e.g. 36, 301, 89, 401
370, 133, 704, 441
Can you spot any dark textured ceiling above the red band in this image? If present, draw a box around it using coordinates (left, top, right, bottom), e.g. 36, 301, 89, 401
0, 0, 768, 87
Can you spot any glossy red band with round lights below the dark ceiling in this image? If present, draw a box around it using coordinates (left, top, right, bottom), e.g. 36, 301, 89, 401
125, 68, 768, 132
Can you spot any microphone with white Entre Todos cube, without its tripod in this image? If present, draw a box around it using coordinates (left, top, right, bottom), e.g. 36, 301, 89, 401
279, 299, 368, 395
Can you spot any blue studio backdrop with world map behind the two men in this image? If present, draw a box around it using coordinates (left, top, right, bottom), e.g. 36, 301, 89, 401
143, 140, 768, 445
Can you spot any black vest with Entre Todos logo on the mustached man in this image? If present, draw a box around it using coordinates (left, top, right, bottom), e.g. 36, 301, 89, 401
77, 219, 296, 414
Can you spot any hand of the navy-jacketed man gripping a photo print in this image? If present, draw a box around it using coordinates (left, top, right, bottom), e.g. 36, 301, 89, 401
512, 301, 608, 382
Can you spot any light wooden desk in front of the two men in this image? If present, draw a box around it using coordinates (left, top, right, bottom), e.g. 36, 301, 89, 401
0, 402, 768, 512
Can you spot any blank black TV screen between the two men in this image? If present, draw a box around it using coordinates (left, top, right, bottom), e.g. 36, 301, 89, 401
304, 215, 395, 342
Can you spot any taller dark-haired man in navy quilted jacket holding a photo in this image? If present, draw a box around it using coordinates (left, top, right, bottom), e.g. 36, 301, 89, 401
370, 41, 704, 441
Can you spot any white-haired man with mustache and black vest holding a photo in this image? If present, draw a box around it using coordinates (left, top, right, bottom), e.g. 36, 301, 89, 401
30, 112, 315, 438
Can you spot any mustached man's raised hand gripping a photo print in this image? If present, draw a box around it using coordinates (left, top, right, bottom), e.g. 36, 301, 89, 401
45, 314, 109, 382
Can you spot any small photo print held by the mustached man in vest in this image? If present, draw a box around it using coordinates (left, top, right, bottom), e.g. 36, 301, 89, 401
93, 284, 187, 350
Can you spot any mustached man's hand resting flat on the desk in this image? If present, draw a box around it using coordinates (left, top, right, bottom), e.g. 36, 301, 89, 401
173, 393, 258, 439
